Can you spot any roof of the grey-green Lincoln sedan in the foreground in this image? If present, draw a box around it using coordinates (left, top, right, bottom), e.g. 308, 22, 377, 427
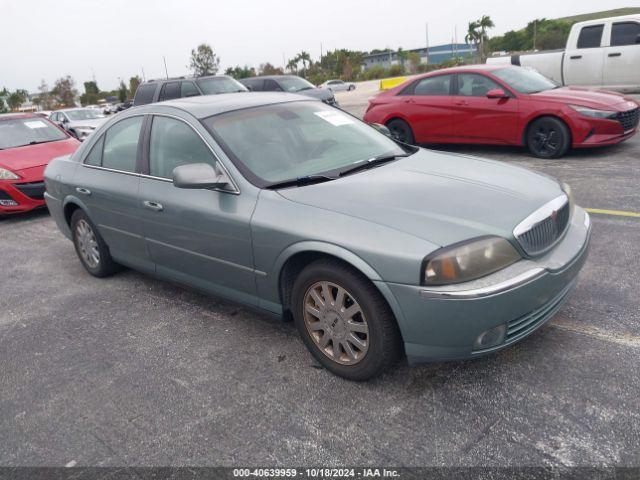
145, 92, 319, 118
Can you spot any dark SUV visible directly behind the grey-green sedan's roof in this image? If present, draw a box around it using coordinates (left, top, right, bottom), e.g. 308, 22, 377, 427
133, 75, 247, 106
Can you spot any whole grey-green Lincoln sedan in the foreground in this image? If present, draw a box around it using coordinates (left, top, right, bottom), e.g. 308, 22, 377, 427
45, 93, 590, 380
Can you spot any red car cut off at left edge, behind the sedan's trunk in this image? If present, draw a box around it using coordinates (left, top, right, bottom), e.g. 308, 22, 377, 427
0, 114, 80, 217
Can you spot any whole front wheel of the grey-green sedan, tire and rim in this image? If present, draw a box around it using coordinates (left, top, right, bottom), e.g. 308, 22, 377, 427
292, 260, 402, 381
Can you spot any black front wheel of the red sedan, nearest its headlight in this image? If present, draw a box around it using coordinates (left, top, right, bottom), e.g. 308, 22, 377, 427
526, 117, 571, 158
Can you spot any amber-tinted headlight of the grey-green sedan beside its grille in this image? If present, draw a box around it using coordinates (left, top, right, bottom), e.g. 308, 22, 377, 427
422, 237, 522, 285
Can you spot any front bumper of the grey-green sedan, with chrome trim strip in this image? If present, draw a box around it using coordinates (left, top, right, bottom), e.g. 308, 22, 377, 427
386, 207, 591, 363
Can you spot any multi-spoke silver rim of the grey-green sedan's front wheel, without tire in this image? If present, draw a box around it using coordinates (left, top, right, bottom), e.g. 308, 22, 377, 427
303, 281, 369, 365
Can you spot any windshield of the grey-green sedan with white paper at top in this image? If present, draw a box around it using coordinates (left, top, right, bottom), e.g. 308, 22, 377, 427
203, 101, 406, 188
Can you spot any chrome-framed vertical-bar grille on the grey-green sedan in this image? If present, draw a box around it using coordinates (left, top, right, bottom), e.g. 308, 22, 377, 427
513, 195, 571, 255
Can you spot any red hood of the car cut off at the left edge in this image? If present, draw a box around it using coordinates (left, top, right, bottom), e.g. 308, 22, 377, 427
0, 138, 80, 174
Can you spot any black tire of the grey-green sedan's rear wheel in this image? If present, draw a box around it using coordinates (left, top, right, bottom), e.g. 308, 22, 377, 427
70, 209, 121, 278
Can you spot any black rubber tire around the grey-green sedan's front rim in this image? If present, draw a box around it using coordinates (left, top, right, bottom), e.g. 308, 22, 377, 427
291, 259, 402, 381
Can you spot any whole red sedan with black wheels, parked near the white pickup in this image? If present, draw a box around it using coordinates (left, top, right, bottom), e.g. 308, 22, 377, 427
364, 65, 640, 158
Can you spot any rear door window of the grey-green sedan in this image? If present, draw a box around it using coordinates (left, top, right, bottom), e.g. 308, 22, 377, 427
102, 116, 144, 172
